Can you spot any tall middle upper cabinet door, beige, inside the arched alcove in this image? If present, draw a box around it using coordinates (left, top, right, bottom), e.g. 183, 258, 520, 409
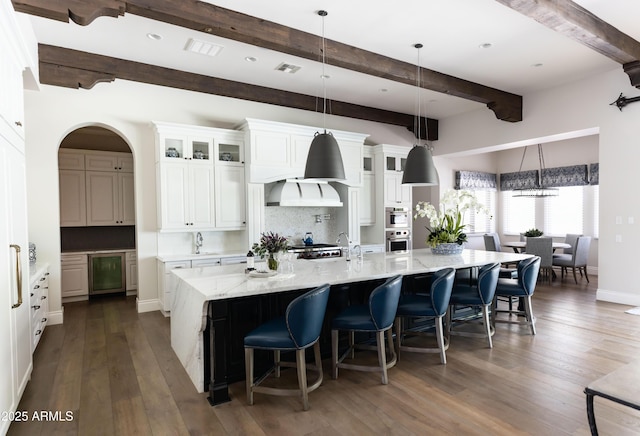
86, 171, 120, 226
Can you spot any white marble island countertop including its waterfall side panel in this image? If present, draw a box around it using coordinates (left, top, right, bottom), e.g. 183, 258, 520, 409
171, 249, 530, 392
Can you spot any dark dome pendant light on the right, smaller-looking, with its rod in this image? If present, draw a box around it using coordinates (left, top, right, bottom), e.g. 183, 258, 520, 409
402, 44, 439, 186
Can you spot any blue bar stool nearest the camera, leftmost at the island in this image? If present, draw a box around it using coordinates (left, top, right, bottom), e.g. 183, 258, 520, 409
244, 284, 329, 410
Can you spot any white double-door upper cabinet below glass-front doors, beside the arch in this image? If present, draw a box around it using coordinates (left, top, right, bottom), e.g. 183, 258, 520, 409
158, 162, 215, 231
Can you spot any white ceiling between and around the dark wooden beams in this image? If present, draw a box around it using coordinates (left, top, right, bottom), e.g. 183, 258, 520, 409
23, 0, 640, 119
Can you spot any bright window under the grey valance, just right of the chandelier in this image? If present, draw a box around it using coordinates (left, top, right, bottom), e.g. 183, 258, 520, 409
542, 186, 588, 236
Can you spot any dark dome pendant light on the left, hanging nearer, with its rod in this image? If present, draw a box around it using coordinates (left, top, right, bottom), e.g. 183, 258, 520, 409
304, 11, 346, 180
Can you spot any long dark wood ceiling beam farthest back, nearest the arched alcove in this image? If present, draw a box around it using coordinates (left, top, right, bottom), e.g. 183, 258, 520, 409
38, 44, 438, 141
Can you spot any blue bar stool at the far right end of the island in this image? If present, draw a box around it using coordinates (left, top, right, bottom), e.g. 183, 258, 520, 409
491, 256, 540, 335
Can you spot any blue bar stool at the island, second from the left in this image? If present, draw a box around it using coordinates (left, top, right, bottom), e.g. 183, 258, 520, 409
331, 275, 402, 385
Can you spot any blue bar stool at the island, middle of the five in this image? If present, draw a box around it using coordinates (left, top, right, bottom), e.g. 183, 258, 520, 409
396, 268, 455, 365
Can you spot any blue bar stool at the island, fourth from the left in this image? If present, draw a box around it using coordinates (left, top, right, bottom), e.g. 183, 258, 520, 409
447, 263, 500, 348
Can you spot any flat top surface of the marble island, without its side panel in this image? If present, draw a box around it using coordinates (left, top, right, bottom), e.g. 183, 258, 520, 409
171, 249, 529, 300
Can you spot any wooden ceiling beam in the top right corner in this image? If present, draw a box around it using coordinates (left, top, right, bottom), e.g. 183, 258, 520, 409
496, 0, 640, 87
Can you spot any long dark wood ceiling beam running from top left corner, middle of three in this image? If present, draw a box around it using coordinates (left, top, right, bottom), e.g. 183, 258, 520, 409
13, 0, 522, 122
